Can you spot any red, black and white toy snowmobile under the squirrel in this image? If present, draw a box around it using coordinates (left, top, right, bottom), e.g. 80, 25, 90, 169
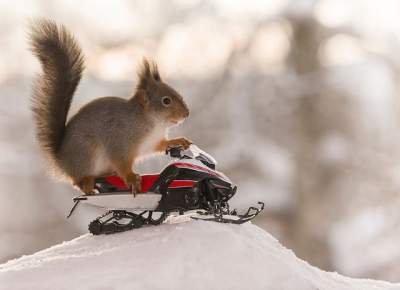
68, 145, 264, 235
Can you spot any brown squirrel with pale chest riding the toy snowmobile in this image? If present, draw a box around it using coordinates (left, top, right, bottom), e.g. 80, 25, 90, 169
31, 20, 191, 193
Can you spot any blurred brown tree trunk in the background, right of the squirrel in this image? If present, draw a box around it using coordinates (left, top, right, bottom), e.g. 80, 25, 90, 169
287, 18, 354, 270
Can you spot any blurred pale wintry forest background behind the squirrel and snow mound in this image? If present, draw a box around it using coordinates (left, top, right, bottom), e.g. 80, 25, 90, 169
0, 0, 400, 282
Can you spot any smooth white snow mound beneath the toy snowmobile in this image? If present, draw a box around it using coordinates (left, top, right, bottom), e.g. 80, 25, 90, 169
0, 221, 400, 290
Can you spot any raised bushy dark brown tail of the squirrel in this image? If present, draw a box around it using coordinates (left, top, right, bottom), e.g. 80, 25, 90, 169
30, 19, 84, 172
